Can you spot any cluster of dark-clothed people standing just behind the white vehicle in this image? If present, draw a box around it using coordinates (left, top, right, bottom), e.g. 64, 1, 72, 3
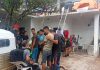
14, 27, 29, 49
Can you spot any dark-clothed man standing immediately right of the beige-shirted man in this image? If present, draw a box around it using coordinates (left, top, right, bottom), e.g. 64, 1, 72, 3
52, 30, 62, 70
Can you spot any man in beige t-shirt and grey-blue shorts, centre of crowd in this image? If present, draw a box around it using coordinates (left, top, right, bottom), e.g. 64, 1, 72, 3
42, 26, 54, 70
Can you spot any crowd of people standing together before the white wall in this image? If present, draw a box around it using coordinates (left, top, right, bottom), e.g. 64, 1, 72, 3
16, 26, 76, 70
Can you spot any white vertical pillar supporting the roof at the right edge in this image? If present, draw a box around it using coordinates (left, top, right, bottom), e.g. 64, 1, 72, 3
94, 14, 99, 57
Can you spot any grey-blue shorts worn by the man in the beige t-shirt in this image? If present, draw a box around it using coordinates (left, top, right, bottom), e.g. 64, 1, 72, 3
42, 50, 52, 63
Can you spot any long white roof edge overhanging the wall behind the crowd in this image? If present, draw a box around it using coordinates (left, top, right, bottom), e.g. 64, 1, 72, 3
28, 9, 100, 19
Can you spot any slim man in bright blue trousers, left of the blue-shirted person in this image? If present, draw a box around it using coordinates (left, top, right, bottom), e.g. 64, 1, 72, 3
31, 28, 38, 62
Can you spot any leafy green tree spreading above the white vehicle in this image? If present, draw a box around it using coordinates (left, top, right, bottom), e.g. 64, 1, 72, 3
0, 0, 54, 24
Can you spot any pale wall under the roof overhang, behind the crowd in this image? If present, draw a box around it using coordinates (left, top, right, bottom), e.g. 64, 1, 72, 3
22, 16, 98, 45
